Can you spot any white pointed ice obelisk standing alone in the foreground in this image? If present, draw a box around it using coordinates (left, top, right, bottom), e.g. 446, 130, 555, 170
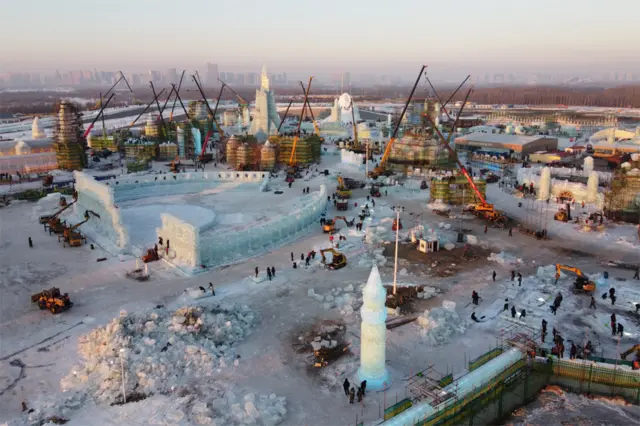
358, 265, 390, 390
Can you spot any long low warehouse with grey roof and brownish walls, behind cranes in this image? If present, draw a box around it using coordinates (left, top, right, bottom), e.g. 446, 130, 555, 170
455, 132, 558, 159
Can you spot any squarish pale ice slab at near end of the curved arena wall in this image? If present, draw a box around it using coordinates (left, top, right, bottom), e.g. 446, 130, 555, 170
157, 213, 200, 268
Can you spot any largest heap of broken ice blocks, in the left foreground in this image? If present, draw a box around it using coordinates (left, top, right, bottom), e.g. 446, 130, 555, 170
37, 305, 286, 425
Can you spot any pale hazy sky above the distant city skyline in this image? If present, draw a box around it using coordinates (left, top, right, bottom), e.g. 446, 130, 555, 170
0, 0, 640, 75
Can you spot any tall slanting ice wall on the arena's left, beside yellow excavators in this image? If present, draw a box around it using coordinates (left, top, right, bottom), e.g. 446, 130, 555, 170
73, 171, 129, 249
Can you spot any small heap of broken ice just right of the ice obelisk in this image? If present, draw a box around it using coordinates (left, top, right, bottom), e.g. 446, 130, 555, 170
417, 300, 468, 346
